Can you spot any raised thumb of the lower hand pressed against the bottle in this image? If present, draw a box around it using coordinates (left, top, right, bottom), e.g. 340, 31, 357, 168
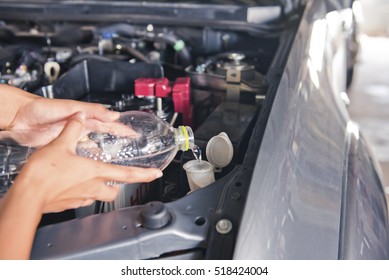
56, 112, 86, 151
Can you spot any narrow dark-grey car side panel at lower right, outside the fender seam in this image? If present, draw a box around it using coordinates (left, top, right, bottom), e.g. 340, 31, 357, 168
339, 132, 389, 259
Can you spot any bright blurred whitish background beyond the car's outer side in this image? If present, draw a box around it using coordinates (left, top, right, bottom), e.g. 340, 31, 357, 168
349, 0, 389, 199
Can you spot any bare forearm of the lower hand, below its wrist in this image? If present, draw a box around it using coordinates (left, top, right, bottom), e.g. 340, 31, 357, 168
0, 178, 41, 260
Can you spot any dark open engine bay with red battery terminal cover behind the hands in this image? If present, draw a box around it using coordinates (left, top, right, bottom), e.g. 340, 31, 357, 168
0, 2, 296, 229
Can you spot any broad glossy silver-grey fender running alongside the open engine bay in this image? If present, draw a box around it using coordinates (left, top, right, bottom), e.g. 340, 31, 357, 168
234, 1, 388, 259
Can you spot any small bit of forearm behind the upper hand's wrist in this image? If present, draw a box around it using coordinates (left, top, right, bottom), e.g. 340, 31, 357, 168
0, 84, 39, 130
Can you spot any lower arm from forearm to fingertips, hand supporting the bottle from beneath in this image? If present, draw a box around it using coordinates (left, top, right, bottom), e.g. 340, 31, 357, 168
0, 113, 162, 259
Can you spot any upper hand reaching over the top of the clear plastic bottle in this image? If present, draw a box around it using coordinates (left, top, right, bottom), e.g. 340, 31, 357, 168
0, 87, 136, 147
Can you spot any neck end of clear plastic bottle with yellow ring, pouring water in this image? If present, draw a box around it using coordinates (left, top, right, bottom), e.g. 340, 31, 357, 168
77, 111, 194, 170
